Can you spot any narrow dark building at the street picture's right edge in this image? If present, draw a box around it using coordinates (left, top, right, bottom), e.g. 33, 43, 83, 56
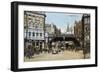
82, 14, 90, 52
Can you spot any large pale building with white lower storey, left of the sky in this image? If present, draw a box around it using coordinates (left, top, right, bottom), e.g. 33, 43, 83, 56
24, 11, 46, 48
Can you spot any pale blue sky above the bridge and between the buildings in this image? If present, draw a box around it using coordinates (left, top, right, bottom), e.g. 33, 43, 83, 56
46, 12, 82, 32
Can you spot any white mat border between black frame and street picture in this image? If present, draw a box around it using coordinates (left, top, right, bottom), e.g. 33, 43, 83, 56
18, 5, 95, 68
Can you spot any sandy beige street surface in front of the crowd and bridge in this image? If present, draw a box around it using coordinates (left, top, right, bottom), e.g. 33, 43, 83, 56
24, 50, 90, 62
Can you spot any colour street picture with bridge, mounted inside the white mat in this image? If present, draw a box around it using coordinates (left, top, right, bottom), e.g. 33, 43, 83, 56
24, 11, 91, 62
